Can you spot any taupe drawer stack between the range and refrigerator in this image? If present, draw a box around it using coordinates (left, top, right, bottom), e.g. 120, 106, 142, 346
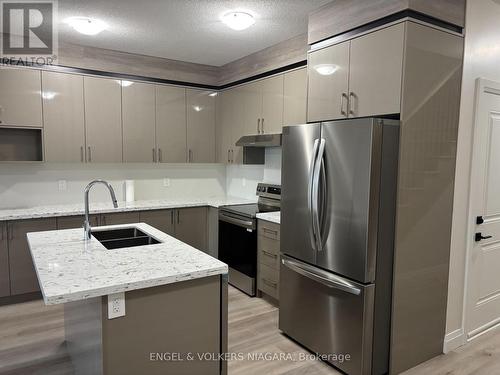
257, 220, 280, 300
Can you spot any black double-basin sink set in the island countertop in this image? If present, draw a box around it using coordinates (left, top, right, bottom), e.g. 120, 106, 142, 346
92, 228, 160, 250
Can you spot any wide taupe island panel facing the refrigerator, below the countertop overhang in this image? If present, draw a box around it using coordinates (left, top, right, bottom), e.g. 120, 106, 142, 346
102, 275, 223, 375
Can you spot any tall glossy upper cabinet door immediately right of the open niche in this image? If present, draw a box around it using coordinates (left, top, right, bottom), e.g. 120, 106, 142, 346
42, 71, 85, 163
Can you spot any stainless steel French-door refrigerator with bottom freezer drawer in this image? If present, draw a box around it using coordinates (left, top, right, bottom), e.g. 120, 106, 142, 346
279, 118, 400, 375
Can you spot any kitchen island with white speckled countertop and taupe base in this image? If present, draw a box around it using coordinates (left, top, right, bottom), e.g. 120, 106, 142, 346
28, 223, 228, 375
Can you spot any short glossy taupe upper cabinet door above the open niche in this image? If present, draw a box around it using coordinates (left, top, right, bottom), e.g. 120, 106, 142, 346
0, 68, 43, 128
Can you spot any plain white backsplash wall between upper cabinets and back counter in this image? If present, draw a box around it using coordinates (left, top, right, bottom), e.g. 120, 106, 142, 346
0, 148, 281, 209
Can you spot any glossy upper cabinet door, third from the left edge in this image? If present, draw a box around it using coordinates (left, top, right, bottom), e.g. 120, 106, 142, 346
84, 77, 122, 163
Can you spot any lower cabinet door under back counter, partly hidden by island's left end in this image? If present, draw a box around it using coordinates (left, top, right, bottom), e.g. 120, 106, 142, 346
8, 218, 57, 295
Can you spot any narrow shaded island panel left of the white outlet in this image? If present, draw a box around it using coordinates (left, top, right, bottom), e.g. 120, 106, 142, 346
64, 297, 102, 375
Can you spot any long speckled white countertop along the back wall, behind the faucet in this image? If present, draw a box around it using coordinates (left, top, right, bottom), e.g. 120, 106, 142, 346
0, 196, 254, 221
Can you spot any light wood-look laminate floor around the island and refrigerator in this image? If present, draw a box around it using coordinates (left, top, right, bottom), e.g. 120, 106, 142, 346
0, 287, 500, 375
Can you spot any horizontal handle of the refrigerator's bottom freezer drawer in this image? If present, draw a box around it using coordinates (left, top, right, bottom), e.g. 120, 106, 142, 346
281, 256, 361, 296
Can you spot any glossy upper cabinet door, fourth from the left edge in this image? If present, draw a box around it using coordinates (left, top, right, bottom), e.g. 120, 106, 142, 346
122, 81, 157, 162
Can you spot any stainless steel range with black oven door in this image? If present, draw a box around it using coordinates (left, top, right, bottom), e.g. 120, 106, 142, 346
219, 183, 281, 296
